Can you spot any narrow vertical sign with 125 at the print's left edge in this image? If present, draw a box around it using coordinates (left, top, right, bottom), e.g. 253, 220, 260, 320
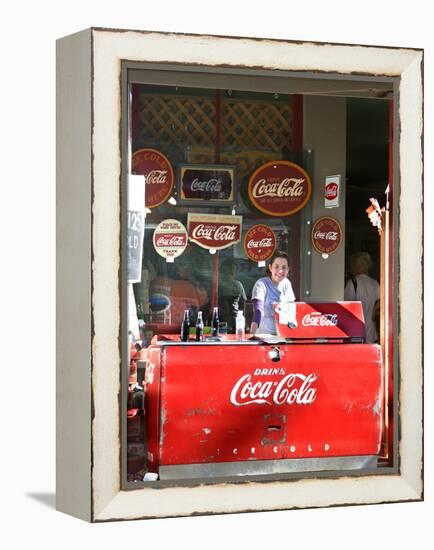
127, 175, 145, 283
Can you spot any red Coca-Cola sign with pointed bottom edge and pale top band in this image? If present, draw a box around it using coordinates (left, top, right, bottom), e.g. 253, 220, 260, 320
187, 214, 243, 252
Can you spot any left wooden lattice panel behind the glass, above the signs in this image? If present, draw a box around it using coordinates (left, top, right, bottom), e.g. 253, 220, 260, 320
139, 94, 215, 151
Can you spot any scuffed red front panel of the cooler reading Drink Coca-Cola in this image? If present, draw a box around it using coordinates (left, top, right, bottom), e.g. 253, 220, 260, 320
146, 343, 383, 471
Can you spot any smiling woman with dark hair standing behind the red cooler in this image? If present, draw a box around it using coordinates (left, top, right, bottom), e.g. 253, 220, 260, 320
250, 252, 295, 336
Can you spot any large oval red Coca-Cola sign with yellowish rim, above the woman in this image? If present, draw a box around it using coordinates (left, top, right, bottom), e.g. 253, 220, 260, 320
248, 160, 312, 216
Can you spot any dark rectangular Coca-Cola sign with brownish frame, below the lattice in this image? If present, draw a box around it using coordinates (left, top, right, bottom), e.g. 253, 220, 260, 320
178, 164, 236, 206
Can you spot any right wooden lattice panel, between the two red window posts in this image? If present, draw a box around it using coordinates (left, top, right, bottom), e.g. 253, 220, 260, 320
222, 100, 292, 151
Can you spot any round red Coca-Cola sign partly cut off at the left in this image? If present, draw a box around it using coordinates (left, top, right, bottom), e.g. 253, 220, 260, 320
131, 149, 175, 208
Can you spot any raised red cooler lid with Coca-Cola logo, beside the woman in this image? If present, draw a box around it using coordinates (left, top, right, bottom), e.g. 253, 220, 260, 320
273, 302, 365, 342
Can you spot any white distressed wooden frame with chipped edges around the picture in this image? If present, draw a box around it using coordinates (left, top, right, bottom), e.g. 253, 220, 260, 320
57, 29, 423, 521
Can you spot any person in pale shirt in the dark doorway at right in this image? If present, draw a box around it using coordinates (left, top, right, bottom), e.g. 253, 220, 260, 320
344, 252, 380, 343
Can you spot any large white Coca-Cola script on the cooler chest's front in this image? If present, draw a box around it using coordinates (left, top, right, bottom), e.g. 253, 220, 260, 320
230, 369, 318, 407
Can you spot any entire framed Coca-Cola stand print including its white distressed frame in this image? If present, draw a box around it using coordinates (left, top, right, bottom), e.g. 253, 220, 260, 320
57, 28, 423, 522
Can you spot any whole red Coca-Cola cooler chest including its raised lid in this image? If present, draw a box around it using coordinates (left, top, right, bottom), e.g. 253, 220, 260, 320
145, 302, 383, 479
